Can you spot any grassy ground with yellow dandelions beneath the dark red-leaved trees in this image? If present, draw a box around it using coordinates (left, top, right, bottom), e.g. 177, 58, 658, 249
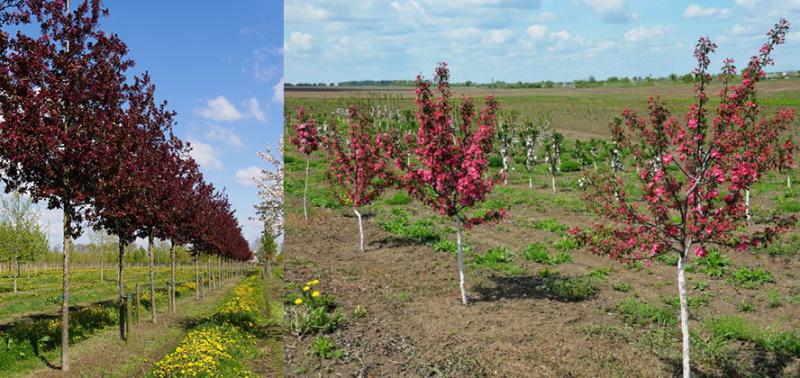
0, 264, 283, 377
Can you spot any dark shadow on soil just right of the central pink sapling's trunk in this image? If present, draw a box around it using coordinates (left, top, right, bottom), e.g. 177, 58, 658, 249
473, 274, 599, 302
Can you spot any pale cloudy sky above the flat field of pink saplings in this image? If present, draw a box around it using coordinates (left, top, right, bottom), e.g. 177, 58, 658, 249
284, 0, 800, 83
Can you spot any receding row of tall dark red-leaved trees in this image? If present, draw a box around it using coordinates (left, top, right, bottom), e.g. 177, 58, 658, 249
0, 0, 251, 371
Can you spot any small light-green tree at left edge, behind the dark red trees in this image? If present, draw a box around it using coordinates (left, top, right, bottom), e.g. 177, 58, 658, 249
0, 192, 47, 294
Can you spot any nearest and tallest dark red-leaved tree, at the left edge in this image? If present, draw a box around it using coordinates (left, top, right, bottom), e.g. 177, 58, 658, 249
0, 0, 132, 371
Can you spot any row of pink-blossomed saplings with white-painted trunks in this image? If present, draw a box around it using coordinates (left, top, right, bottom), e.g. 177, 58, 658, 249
292, 19, 795, 377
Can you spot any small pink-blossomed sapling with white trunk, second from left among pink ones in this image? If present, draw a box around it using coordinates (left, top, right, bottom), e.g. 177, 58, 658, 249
322, 106, 393, 252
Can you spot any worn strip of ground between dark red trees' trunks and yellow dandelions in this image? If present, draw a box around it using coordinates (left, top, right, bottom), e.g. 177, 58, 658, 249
17, 277, 241, 378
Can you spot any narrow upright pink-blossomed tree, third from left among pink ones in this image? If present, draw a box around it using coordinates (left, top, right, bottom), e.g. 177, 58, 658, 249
395, 63, 504, 305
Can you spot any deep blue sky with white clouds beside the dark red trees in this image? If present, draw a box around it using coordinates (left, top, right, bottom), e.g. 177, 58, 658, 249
35, 0, 283, 250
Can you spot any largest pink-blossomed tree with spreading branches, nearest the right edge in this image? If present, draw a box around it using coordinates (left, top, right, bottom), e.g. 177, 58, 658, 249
573, 20, 794, 377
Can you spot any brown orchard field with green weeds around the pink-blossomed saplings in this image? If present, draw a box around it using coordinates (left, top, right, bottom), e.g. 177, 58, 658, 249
284, 76, 800, 377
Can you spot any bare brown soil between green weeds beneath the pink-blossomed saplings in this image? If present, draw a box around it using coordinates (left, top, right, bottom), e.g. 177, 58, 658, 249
285, 185, 800, 377
